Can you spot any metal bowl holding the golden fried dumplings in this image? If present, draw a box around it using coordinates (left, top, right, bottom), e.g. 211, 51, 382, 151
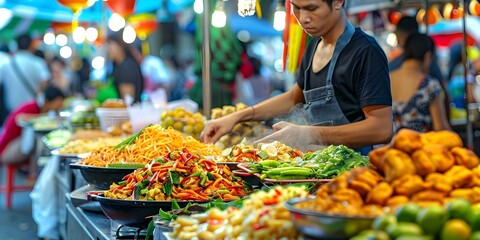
285, 198, 375, 240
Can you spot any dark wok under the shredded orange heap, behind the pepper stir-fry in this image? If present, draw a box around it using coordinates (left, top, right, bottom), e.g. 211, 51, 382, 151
70, 163, 136, 190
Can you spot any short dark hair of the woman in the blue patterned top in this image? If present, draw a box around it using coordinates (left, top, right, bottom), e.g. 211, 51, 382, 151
404, 33, 435, 61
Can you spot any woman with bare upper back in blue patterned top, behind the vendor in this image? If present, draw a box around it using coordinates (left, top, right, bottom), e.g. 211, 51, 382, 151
390, 33, 450, 132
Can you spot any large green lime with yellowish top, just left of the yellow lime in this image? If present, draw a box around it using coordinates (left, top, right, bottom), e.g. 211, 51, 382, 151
417, 206, 448, 236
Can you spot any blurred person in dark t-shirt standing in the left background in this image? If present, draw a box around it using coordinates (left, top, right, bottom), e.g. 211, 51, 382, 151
107, 34, 144, 102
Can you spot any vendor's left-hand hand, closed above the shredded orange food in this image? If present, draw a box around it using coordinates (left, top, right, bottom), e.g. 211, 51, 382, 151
200, 116, 238, 143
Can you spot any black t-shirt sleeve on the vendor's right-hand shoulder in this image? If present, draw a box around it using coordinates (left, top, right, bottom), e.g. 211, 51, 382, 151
354, 44, 392, 108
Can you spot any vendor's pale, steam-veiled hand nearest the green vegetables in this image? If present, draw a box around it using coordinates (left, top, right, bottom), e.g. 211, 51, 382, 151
254, 121, 313, 148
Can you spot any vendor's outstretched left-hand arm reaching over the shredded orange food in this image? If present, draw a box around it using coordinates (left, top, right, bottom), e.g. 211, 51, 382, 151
201, 84, 304, 143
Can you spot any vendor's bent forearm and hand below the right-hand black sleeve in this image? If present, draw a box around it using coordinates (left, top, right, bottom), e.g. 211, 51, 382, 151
256, 105, 393, 148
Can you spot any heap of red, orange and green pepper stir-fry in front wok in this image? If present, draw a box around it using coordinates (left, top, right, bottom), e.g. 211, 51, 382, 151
105, 148, 250, 201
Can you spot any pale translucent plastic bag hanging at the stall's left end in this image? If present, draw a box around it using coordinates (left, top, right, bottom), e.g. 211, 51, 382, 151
30, 157, 60, 239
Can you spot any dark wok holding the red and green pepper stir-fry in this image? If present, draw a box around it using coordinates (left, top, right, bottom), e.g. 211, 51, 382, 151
87, 191, 206, 227
